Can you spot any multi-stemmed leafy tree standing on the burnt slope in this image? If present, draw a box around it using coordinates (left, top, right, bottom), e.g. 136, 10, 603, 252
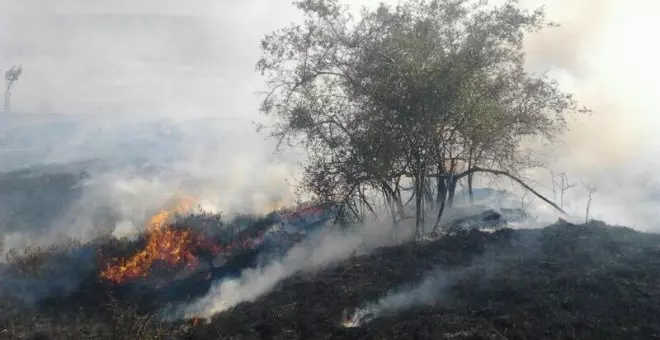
257, 0, 575, 234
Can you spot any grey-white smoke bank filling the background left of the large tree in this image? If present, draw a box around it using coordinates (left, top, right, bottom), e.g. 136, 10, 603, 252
0, 0, 310, 251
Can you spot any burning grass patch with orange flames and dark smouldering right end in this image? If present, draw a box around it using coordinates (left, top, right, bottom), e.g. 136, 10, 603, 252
99, 197, 274, 284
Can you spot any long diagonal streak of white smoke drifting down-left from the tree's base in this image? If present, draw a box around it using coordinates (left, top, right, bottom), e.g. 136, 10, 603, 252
175, 218, 414, 318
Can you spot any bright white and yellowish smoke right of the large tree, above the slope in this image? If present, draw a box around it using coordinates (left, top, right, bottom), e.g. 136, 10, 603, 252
522, 0, 660, 231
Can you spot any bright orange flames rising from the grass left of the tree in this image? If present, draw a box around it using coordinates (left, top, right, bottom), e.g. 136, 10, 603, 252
100, 197, 204, 283
